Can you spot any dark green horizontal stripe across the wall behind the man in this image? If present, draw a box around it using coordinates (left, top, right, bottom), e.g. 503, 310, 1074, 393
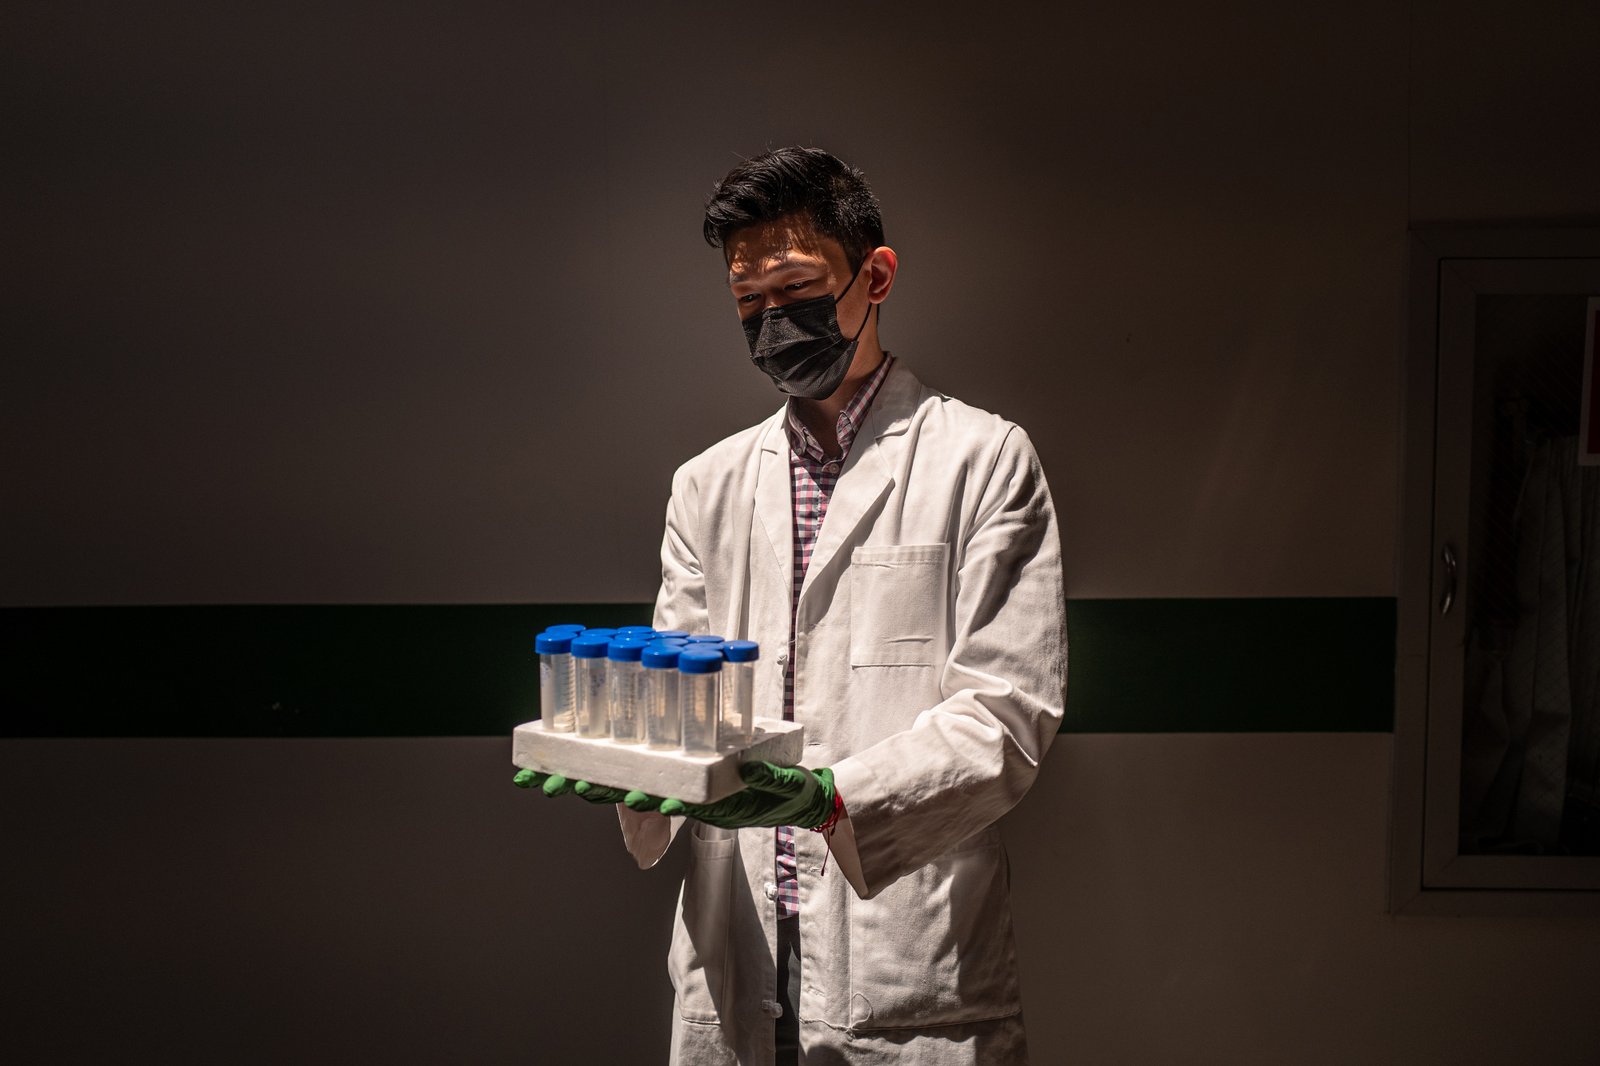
0, 599, 1395, 736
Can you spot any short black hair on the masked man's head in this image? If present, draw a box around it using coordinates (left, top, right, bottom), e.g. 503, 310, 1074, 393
704, 144, 883, 271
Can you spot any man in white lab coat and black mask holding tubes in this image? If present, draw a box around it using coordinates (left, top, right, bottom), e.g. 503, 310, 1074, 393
531, 147, 1066, 1066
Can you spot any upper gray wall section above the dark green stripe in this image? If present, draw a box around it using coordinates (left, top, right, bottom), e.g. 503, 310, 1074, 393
0, 3, 1433, 603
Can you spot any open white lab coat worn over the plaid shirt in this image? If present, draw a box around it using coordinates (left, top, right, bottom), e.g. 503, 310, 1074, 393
618, 363, 1067, 1066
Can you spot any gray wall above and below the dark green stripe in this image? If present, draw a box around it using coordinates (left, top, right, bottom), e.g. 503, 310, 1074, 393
9, 0, 1600, 1064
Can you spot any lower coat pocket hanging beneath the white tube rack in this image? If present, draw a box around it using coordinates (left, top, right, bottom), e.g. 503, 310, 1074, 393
667, 821, 742, 1023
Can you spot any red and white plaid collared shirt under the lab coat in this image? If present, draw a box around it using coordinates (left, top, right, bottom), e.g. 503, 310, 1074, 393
774, 352, 894, 917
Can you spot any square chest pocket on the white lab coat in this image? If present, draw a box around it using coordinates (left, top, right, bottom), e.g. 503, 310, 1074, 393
850, 544, 950, 666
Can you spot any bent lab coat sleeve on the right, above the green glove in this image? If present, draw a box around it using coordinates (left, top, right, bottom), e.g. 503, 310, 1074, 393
830, 426, 1067, 898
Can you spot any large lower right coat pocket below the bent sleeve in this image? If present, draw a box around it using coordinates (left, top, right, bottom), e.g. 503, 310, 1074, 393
848, 829, 1021, 1029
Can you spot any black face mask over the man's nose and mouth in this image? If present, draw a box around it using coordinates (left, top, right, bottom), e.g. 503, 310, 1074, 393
742, 271, 872, 400
